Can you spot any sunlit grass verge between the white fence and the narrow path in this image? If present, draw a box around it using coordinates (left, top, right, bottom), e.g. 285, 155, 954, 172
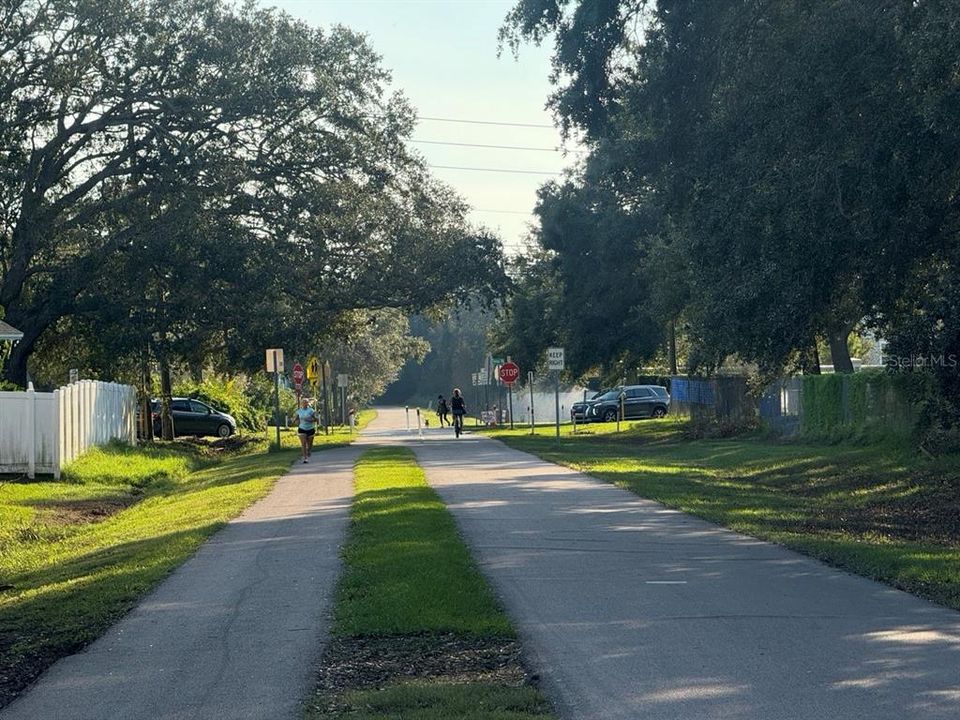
0, 415, 371, 706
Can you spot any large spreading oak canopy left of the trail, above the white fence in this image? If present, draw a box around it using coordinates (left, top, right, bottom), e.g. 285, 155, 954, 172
0, 0, 505, 414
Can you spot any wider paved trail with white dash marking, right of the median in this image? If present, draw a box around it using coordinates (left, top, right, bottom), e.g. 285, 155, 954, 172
371, 411, 960, 720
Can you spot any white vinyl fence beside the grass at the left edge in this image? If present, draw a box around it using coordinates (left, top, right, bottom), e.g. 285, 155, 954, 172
0, 380, 137, 478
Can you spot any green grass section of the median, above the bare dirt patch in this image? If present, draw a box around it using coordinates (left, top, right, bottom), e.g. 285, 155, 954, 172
333, 448, 513, 637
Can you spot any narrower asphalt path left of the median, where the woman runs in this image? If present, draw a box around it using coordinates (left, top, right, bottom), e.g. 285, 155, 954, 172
0, 446, 360, 720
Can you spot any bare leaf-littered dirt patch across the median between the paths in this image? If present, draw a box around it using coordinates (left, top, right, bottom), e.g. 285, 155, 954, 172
315, 634, 534, 712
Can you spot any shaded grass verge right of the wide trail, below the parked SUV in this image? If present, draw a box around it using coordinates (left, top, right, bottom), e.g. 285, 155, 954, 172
492, 419, 960, 609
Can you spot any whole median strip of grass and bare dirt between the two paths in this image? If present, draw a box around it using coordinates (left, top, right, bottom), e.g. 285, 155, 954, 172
307, 448, 552, 720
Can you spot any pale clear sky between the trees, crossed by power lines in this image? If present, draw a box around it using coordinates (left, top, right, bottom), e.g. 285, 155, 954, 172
264, 0, 574, 250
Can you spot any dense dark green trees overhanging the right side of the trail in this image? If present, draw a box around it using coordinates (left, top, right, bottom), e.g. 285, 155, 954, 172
497, 0, 960, 428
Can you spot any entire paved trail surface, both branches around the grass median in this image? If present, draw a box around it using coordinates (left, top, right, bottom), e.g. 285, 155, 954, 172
7, 410, 960, 720
